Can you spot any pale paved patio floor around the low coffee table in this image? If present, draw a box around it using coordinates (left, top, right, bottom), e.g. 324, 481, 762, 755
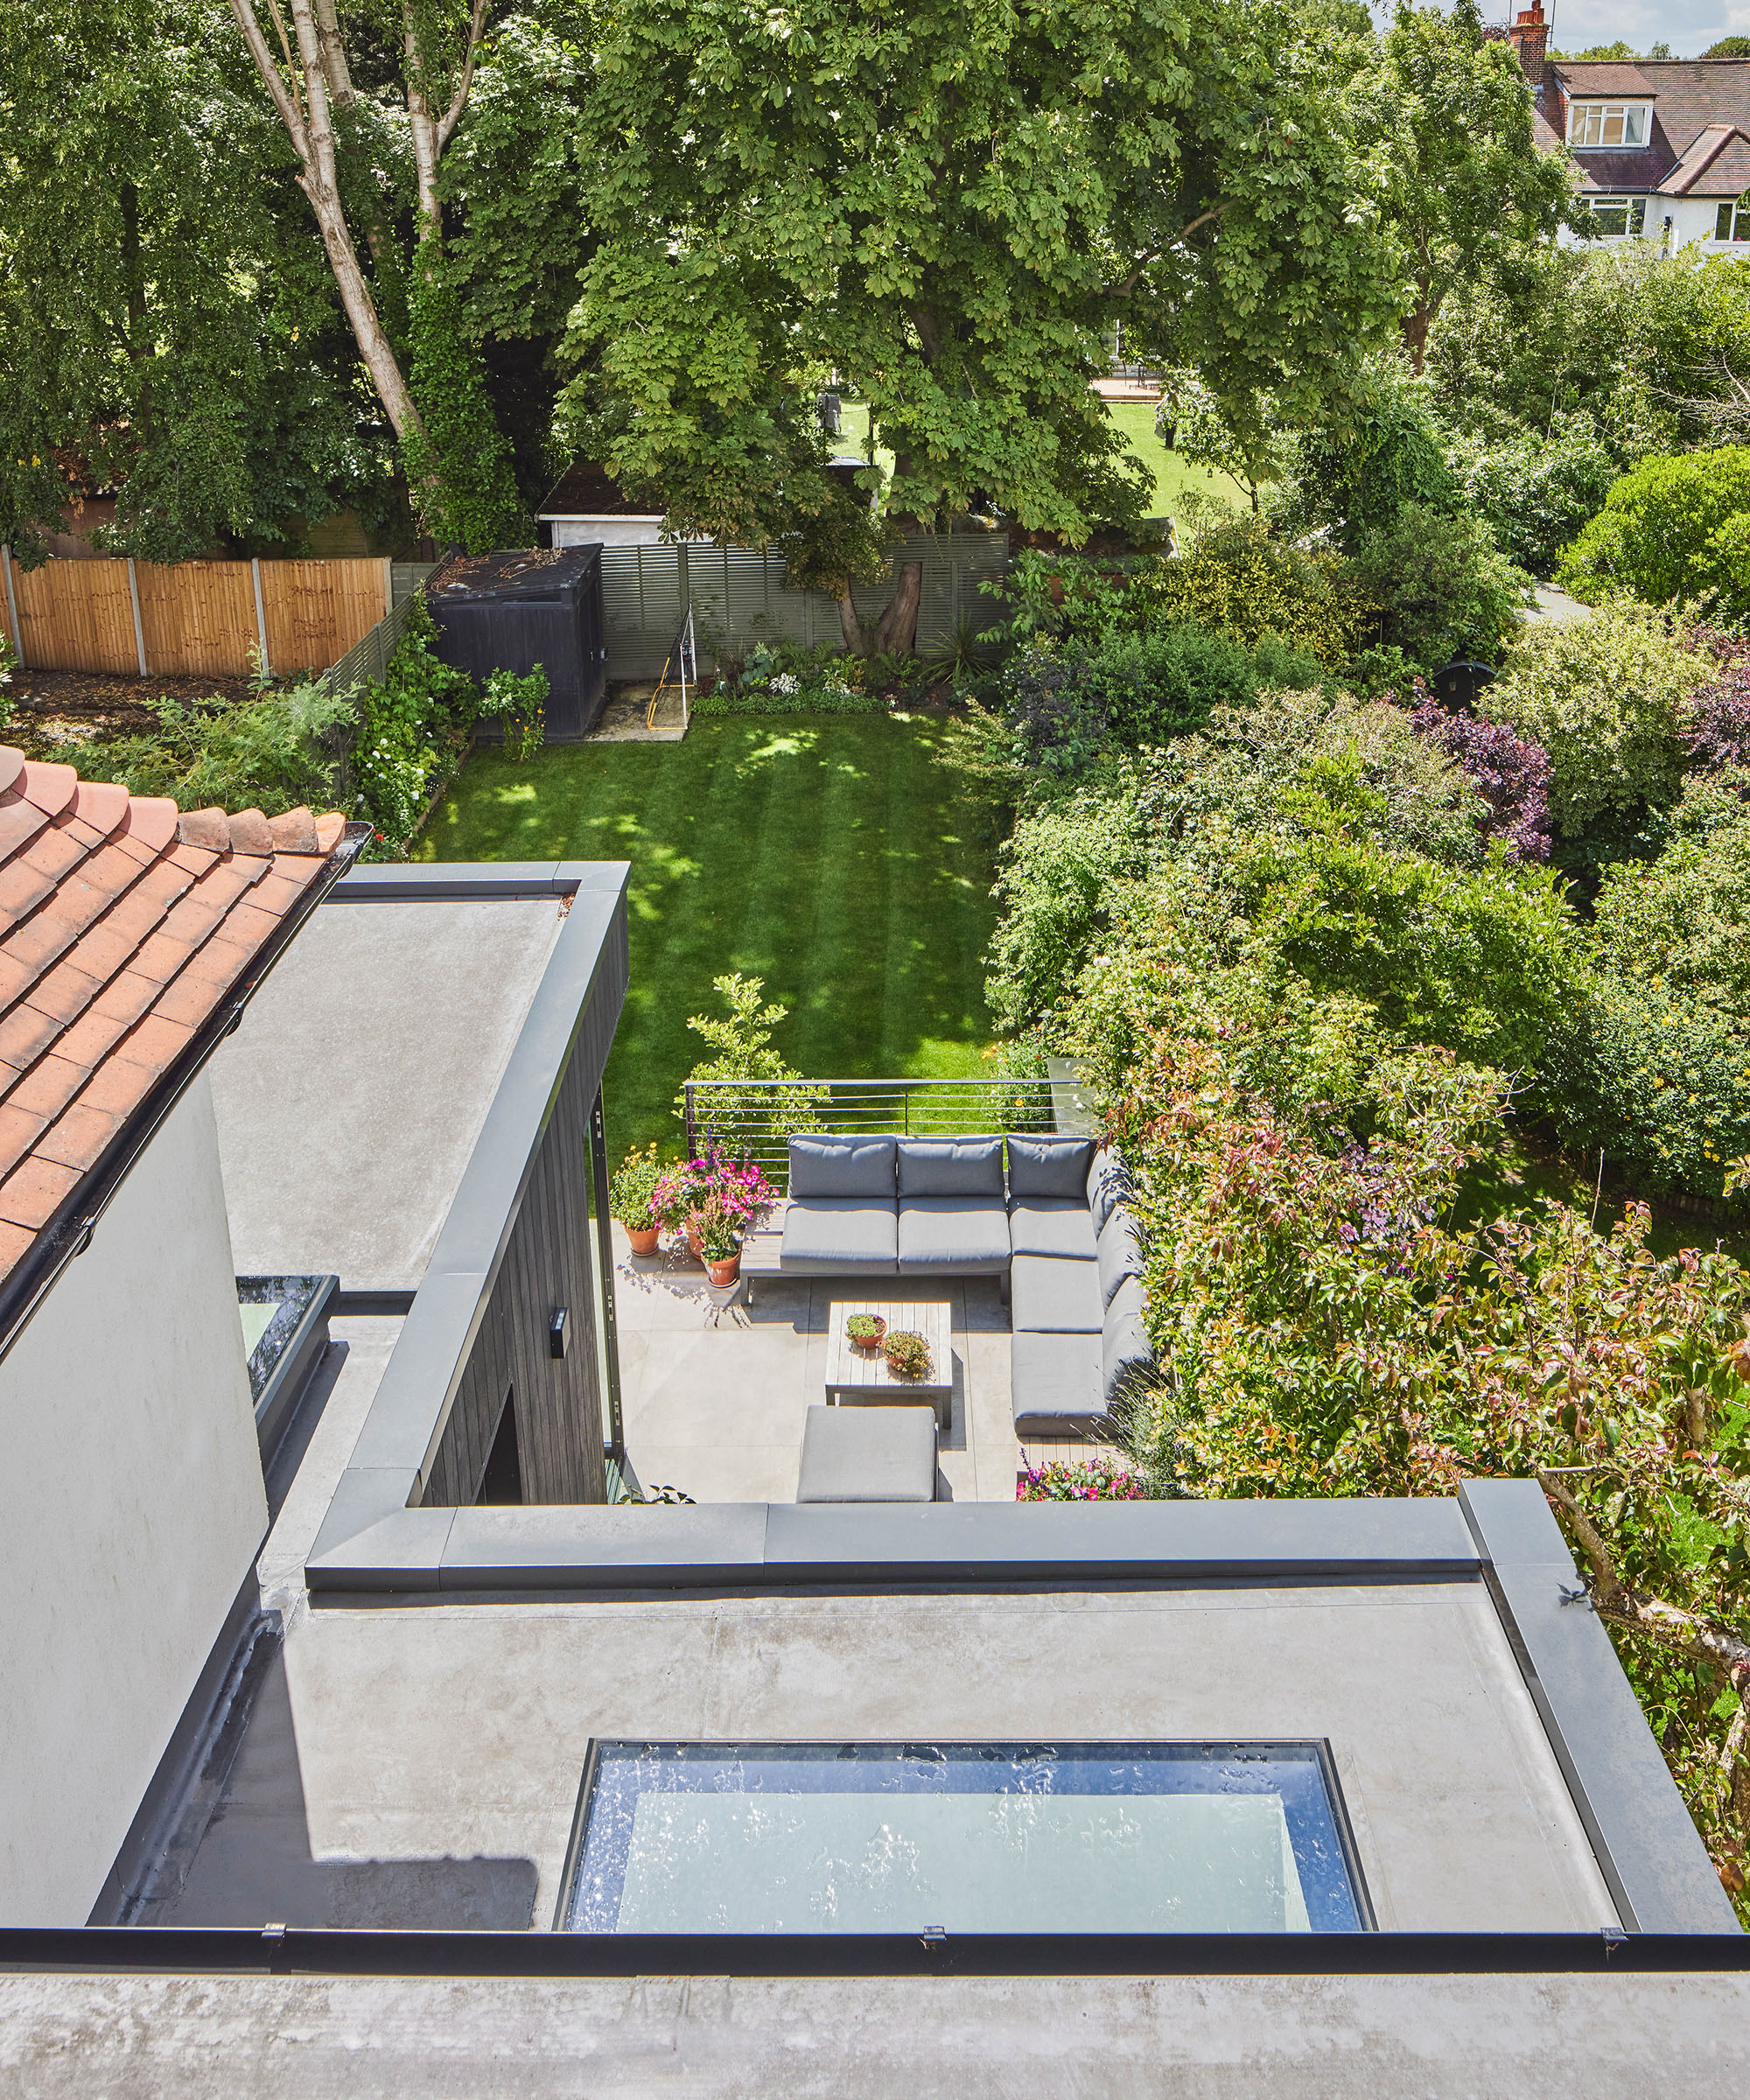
613, 1224, 1092, 1502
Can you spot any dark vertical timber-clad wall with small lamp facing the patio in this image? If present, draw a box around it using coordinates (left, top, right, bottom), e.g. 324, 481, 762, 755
423, 1037, 607, 1506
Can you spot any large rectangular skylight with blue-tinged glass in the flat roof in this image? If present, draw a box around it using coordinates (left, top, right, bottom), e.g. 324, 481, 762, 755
555, 1743, 1372, 1934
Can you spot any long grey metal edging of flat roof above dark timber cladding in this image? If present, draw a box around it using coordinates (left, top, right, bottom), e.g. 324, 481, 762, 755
311, 861, 630, 1590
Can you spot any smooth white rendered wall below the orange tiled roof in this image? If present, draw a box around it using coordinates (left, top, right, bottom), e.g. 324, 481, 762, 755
0, 1077, 267, 1926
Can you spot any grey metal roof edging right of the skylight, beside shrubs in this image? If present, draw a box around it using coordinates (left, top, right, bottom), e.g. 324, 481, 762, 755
1458, 1480, 1740, 1932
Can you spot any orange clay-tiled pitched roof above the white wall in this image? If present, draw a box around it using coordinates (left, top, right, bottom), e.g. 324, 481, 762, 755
0, 746, 346, 1277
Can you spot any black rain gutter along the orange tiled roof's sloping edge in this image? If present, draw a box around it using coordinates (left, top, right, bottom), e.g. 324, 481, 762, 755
0, 823, 370, 1361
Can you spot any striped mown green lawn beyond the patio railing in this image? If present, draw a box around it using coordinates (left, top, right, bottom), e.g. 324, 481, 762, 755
414, 716, 996, 1159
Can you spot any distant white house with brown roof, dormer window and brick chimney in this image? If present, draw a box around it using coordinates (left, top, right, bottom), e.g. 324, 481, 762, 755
1485, 0, 1750, 254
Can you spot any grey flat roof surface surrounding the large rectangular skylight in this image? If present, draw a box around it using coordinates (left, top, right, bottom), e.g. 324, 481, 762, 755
133, 1581, 1618, 1932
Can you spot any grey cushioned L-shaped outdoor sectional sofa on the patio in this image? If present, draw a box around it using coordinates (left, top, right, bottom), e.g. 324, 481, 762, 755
742, 1134, 1153, 1438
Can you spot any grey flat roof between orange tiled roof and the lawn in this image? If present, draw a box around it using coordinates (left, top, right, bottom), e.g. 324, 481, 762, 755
210, 890, 563, 1292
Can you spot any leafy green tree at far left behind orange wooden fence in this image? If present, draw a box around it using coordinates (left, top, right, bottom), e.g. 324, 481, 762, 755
0, 0, 393, 561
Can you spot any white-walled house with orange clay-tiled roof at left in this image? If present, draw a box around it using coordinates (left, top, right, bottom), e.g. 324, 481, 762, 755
0, 750, 363, 1926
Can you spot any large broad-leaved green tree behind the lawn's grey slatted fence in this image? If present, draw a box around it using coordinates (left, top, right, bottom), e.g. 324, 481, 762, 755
565, 0, 1399, 651
